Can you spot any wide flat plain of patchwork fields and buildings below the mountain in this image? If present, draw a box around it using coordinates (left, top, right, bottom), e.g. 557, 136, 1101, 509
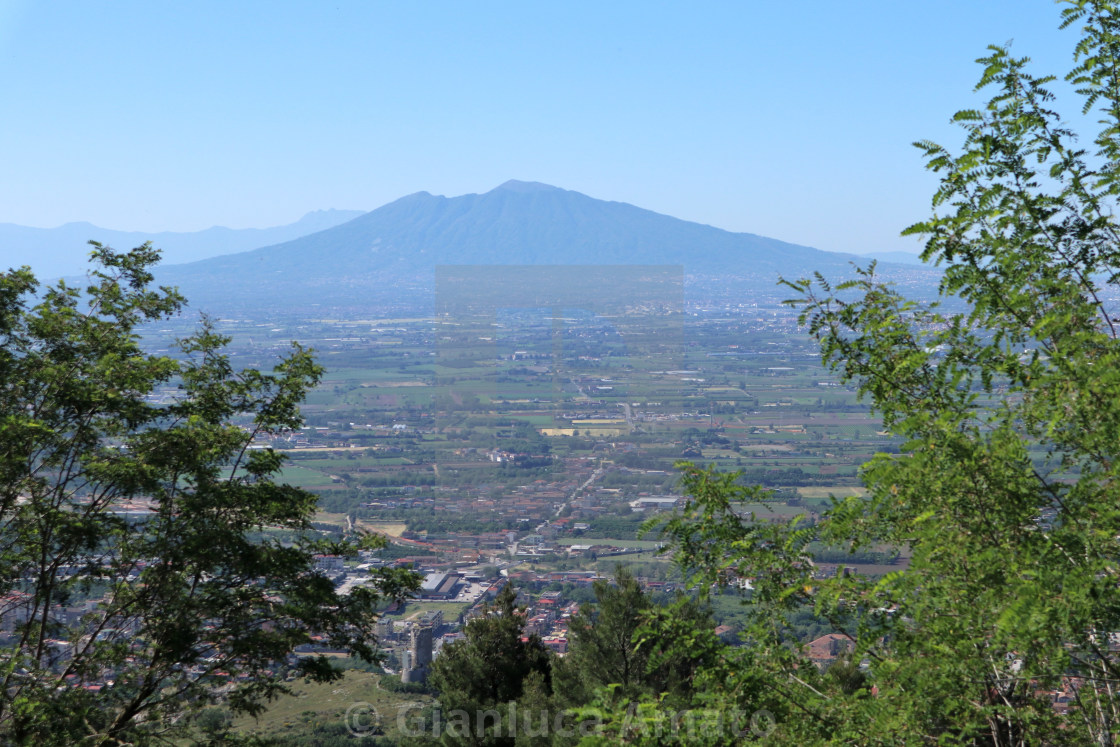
199, 304, 897, 577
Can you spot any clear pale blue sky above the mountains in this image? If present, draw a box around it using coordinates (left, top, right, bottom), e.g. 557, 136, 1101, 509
0, 0, 1076, 252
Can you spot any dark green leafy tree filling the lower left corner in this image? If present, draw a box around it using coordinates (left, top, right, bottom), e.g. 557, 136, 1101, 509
0, 243, 416, 745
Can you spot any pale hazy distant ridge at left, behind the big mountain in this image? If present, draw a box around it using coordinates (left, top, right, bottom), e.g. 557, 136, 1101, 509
0, 209, 362, 278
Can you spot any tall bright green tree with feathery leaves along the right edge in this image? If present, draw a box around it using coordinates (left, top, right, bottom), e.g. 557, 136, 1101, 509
636, 0, 1120, 745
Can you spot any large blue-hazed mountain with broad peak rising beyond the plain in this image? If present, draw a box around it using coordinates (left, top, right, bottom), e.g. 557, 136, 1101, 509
160, 181, 927, 312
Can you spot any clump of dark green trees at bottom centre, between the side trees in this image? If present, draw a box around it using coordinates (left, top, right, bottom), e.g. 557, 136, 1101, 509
414, 568, 737, 747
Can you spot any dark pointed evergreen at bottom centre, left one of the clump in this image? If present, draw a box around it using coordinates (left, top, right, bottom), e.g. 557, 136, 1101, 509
430, 583, 552, 745
